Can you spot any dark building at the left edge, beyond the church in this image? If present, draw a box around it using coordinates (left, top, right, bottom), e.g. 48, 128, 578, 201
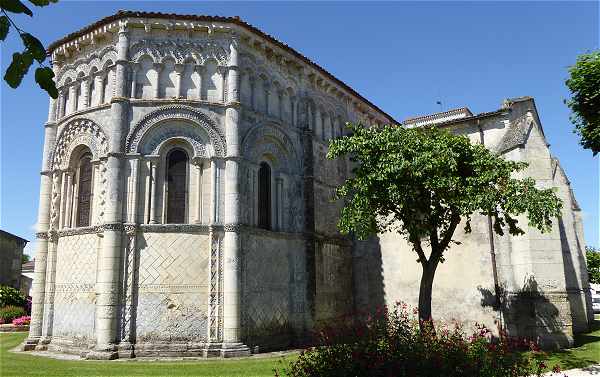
0, 230, 29, 289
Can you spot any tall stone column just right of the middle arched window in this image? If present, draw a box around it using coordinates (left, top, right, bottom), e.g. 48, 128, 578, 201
221, 39, 250, 357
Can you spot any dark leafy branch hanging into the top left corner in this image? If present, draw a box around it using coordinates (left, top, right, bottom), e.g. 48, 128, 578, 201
0, 0, 58, 98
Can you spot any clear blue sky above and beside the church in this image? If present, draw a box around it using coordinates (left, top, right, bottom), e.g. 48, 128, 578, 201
0, 1, 600, 252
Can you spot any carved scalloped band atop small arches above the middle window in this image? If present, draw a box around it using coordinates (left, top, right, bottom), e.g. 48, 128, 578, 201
129, 38, 230, 65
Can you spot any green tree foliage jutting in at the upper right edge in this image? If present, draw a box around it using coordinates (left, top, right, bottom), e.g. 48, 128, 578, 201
566, 51, 600, 156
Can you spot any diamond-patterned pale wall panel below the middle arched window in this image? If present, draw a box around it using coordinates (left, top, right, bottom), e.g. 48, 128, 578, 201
136, 233, 210, 342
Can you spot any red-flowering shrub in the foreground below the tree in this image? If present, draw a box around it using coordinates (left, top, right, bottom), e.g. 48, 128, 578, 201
276, 305, 545, 377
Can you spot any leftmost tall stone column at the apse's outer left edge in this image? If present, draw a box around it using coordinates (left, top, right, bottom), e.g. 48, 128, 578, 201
23, 90, 60, 351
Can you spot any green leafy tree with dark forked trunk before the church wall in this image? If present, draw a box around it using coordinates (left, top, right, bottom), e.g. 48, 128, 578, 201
327, 124, 562, 323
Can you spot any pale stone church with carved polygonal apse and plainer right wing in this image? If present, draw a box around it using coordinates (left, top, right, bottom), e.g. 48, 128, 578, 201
24, 11, 590, 359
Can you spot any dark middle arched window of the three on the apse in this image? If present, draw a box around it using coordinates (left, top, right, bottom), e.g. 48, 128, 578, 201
166, 149, 188, 224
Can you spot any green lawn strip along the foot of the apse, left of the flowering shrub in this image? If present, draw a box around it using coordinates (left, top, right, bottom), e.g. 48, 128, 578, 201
0, 333, 295, 377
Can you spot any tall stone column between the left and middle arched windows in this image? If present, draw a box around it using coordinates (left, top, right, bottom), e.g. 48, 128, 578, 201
87, 21, 129, 359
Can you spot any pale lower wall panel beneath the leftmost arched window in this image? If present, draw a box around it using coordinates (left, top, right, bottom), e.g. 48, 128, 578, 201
53, 233, 101, 347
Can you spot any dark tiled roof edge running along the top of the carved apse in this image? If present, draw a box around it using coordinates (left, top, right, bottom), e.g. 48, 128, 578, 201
48, 10, 400, 124
